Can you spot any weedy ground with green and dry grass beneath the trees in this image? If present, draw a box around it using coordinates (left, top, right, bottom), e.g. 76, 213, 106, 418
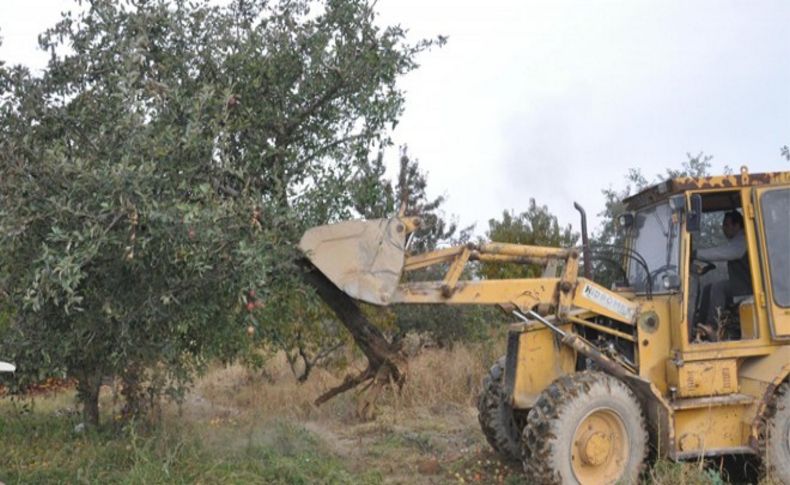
0, 345, 772, 485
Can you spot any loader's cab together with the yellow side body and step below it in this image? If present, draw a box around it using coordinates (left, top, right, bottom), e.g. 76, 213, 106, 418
615, 167, 790, 476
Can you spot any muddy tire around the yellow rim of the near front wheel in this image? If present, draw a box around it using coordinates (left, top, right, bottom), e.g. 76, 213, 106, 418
522, 371, 648, 485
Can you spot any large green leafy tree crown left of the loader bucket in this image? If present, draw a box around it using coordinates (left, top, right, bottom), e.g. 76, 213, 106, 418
0, 0, 440, 425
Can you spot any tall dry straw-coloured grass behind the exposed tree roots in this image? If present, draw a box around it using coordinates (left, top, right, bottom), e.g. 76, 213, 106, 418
192, 336, 499, 419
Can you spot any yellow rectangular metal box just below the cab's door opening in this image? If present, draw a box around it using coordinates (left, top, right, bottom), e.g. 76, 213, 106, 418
667, 359, 738, 397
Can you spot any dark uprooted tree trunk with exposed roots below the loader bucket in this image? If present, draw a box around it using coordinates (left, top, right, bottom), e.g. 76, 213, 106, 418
297, 258, 406, 412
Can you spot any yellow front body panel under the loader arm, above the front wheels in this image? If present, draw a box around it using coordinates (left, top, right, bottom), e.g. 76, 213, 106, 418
513, 325, 576, 409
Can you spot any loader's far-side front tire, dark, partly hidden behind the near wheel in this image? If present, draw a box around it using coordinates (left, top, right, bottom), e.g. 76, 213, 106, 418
477, 357, 521, 461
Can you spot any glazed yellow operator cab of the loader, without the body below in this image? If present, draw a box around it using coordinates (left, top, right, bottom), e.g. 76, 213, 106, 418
625, 168, 790, 356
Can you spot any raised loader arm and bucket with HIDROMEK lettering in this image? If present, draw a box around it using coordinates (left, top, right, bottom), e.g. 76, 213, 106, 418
300, 217, 638, 376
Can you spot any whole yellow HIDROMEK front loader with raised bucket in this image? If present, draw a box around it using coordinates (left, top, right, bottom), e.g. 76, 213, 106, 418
300, 168, 790, 484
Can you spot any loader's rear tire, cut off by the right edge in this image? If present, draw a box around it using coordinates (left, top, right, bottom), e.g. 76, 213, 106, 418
762, 383, 790, 485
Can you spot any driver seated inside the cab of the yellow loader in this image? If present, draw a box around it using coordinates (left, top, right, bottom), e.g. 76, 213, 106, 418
695, 210, 752, 340
